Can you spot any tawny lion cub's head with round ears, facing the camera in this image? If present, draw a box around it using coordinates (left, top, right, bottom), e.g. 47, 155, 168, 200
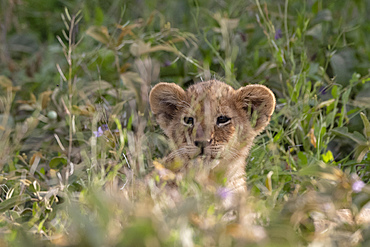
149, 80, 275, 168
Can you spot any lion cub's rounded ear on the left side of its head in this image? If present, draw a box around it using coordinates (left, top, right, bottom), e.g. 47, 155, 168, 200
149, 82, 186, 130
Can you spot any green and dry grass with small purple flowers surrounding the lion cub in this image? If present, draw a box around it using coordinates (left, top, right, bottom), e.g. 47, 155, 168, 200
0, 0, 370, 246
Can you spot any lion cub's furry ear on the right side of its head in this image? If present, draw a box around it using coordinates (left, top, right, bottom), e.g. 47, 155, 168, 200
236, 85, 275, 132
